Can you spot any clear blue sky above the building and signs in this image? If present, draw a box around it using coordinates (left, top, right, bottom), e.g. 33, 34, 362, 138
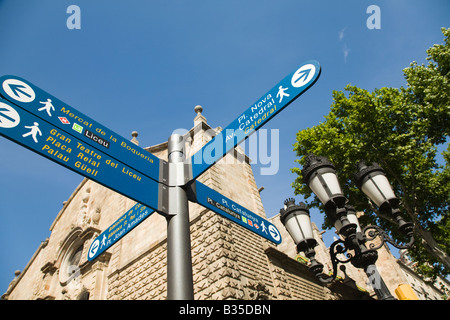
0, 0, 450, 293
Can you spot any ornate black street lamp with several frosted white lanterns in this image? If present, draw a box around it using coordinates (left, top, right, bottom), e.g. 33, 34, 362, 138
280, 154, 414, 300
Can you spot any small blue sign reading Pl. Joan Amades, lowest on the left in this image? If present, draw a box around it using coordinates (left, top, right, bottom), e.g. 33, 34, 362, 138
88, 203, 154, 261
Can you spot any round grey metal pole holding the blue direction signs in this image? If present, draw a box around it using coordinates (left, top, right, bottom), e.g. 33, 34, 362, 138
167, 134, 194, 300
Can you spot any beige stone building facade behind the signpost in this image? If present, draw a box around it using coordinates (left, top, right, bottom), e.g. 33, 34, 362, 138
2, 106, 442, 300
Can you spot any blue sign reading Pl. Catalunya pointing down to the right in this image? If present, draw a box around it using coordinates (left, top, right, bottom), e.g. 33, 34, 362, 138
190, 181, 281, 244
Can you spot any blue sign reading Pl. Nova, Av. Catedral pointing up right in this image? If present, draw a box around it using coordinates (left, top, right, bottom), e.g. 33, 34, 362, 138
191, 60, 321, 179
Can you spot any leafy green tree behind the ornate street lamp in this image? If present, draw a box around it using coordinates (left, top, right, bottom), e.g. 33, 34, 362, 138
292, 28, 450, 278
